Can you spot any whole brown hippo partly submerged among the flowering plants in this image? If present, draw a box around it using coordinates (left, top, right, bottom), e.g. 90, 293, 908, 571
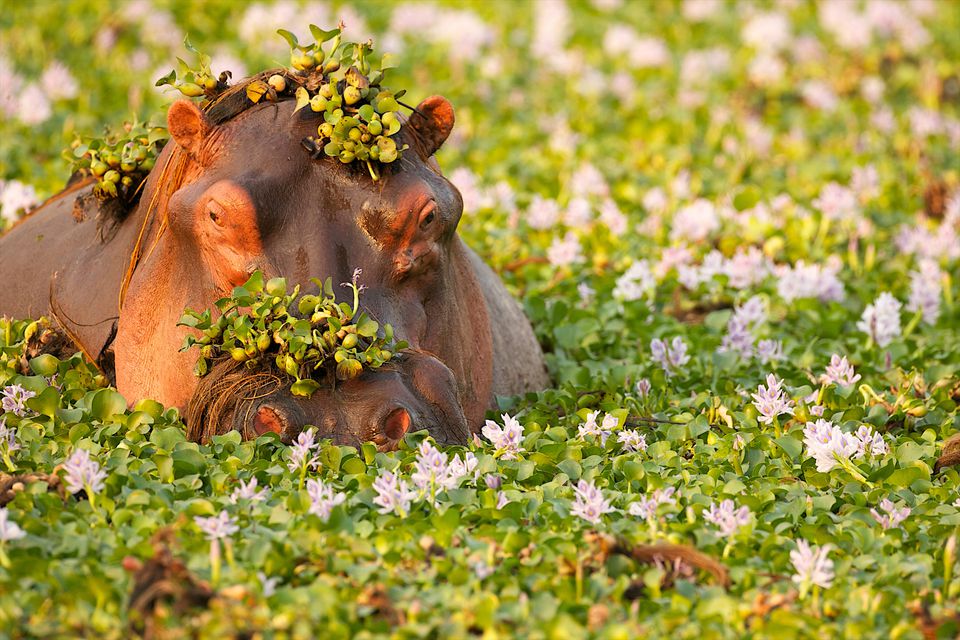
0, 71, 548, 446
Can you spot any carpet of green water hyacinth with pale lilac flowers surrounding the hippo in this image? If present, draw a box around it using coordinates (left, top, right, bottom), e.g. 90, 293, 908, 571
0, 0, 960, 640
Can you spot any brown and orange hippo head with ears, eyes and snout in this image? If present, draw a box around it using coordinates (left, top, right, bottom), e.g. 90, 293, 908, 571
114, 75, 492, 445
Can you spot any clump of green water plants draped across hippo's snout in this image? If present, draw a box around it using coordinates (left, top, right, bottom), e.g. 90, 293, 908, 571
179, 269, 407, 397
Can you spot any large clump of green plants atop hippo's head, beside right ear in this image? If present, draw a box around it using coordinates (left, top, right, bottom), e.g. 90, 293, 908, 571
270, 25, 407, 181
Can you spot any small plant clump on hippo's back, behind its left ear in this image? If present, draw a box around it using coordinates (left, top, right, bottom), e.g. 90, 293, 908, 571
64, 122, 168, 205
